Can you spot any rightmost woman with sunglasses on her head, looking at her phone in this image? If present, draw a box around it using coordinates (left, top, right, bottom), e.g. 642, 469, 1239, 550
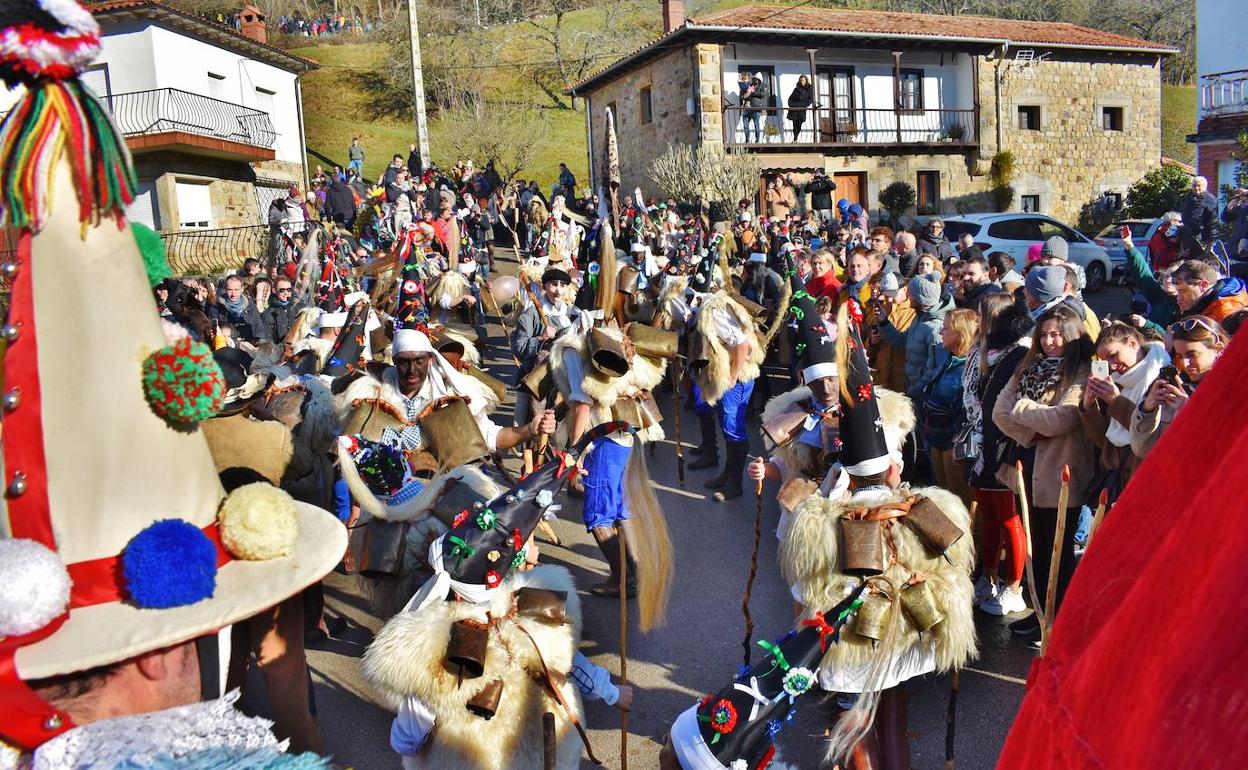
1131, 316, 1231, 458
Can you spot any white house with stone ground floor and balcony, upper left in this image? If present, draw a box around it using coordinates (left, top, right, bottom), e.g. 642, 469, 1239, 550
0, 0, 317, 270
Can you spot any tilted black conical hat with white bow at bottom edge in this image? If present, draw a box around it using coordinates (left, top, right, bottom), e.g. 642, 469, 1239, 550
696, 587, 862, 770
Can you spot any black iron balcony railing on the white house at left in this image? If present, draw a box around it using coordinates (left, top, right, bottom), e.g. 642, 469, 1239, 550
100, 89, 277, 147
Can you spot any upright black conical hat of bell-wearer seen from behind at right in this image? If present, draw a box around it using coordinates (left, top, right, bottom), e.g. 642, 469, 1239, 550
837, 297, 890, 475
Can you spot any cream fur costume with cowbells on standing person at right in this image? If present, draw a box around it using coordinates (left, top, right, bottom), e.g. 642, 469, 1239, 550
780, 487, 977, 671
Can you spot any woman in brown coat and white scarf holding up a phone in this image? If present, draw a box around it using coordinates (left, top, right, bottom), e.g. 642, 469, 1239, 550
1080, 321, 1171, 504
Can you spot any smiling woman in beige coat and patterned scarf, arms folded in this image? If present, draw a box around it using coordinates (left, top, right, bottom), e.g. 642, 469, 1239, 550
992, 305, 1094, 644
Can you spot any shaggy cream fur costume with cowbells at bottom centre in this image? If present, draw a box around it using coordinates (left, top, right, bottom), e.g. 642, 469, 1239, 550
363, 565, 583, 770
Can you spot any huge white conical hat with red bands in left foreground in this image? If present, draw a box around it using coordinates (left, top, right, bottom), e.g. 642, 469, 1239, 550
0, 160, 347, 680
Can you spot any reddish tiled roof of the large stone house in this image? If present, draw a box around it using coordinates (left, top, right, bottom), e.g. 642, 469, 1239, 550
689, 5, 1176, 51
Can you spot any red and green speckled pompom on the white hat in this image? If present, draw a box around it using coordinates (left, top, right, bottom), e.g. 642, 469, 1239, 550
142, 337, 226, 428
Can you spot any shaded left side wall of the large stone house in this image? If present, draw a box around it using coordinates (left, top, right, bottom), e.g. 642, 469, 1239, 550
590, 46, 703, 195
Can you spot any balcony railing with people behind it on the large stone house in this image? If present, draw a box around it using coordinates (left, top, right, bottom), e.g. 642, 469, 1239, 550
724, 106, 980, 150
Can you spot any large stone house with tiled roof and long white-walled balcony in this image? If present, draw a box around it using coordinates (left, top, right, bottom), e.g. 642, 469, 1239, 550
568, 0, 1174, 221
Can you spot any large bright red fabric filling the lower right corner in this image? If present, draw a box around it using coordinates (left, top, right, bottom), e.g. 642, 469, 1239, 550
997, 339, 1248, 770
